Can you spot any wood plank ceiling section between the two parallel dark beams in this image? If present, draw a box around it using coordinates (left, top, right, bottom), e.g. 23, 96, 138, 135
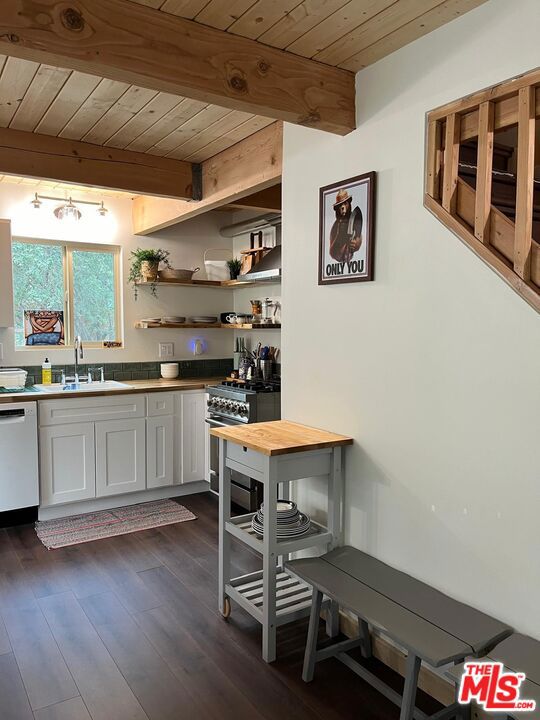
0, 55, 273, 163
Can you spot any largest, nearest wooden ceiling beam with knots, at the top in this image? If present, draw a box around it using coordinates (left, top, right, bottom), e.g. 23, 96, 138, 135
0, 0, 355, 135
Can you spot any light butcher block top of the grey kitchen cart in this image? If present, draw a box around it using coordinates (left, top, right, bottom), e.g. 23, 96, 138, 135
210, 420, 353, 455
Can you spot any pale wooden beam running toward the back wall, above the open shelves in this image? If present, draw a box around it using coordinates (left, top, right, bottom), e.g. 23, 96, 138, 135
132, 122, 283, 235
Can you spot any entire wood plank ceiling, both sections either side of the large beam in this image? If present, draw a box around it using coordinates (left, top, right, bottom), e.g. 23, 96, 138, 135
0, 0, 485, 194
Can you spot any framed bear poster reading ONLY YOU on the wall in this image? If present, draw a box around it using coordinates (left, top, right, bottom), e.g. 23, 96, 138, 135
319, 172, 375, 285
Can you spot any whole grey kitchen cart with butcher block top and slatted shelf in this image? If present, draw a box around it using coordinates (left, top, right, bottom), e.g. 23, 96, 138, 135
210, 420, 353, 662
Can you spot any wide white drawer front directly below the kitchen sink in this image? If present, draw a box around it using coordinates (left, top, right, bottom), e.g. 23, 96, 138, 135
39, 395, 146, 427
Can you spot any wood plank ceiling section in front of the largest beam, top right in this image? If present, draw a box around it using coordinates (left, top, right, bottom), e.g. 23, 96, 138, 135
127, 0, 486, 72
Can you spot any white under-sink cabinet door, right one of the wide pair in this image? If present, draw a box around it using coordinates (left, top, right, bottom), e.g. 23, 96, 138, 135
96, 418, 146, 497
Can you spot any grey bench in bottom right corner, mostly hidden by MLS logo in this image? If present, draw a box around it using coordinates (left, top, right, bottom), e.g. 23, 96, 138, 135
447, 633, 540, 720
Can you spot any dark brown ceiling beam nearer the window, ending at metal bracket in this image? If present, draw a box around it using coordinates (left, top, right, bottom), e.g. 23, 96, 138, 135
0, 128, 197, 198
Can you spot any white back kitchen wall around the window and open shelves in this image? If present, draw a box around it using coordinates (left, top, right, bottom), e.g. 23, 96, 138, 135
0, 183, 234, 365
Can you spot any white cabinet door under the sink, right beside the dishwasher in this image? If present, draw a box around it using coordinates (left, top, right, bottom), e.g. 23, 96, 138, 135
39, 423, 96, 506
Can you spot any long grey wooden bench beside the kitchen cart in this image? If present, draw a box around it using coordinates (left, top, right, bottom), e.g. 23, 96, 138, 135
286, 547, 512, 720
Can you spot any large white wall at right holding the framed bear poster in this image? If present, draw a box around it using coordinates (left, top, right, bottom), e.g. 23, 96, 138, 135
282, 0, 540, 638
